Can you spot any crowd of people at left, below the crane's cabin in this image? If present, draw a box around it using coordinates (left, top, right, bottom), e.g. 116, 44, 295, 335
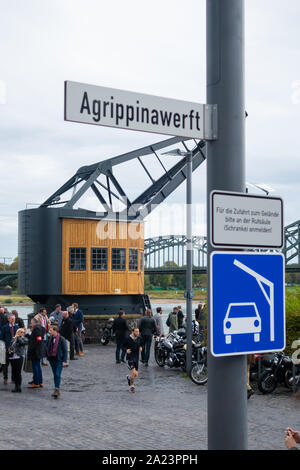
0, 303, 84, 398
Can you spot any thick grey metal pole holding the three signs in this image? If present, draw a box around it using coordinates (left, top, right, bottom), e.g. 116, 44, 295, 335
207, 0, 248, 450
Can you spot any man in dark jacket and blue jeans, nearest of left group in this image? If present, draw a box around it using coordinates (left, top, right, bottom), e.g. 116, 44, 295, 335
47, 326, 68, 398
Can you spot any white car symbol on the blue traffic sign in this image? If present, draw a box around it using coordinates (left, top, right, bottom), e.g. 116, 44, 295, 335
223, 302, 261, 344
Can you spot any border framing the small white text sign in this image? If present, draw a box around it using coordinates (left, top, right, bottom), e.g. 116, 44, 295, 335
209, 189, 284, 250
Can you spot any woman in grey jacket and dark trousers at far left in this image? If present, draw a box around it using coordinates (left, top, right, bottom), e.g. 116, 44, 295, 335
9, 328, 28, 393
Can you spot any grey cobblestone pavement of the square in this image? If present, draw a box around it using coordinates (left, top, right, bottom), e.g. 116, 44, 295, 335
0, 345, 300, 450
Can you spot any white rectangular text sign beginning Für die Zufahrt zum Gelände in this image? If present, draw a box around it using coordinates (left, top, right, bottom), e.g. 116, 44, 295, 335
210, 191, 284, 249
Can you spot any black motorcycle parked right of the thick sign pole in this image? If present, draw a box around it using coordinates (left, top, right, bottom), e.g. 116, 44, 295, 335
258, 352, 299, 394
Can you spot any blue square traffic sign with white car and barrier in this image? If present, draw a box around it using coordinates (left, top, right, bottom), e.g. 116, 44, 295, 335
210, 252, 285, 356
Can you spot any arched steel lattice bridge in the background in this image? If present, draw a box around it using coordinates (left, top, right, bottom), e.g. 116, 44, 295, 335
145, 220, 300, 274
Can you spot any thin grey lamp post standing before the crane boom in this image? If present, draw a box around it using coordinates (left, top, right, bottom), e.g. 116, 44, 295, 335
162, 149, 193, 374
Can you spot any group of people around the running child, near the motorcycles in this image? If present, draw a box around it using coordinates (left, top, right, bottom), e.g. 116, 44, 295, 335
113, 304, 205, 393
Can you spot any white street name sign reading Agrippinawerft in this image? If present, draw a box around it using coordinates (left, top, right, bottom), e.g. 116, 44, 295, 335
64, 81, 217, 140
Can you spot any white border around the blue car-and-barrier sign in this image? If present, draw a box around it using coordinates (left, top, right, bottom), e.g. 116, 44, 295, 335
209, 251, 286, 357
